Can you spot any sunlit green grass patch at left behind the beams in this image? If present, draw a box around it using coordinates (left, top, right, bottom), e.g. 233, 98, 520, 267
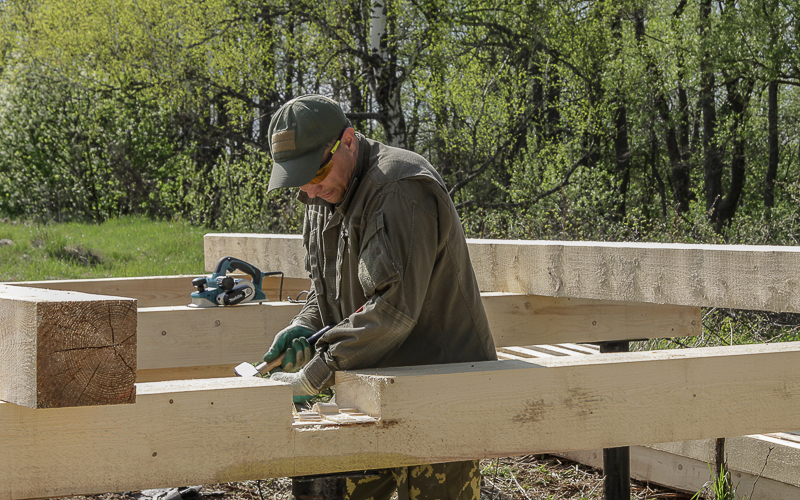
0, 217, 206, 282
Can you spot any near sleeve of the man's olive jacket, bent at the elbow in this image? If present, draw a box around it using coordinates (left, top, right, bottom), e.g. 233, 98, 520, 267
305, 179, 449, 388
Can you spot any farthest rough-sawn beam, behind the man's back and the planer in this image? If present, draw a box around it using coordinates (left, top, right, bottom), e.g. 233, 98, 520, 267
204, 234, 800, 312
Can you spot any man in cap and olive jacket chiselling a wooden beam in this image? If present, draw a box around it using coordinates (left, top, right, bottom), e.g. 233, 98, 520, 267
264, 95, 497, 500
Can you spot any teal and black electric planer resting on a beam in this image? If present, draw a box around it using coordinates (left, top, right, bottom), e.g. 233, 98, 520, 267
189, 257, 283, 307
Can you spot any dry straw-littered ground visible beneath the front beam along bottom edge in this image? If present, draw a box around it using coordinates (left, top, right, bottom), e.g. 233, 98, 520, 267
53, 455, 690, 500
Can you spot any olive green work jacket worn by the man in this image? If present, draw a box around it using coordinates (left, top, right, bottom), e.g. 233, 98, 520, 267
292, 134, 497, 389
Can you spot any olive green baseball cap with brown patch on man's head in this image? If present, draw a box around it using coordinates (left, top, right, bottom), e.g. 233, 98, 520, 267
268, 94, 348, 191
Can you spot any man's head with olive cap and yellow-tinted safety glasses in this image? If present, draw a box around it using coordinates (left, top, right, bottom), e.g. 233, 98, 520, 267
269, 95, 354, 199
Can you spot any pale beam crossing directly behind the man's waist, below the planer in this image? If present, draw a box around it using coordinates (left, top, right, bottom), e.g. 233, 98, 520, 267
137, 293, 701, 382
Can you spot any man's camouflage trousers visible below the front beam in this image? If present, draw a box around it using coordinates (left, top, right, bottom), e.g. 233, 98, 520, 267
345, 460, 481, 500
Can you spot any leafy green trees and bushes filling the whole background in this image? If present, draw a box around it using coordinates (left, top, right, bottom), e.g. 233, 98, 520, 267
0, 0, 800, 240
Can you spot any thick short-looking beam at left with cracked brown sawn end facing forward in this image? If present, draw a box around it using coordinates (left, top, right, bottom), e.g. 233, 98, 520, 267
0, 285, 137, 408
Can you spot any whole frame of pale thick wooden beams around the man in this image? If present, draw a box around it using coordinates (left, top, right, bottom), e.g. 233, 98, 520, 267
0, 234, 800, 500
